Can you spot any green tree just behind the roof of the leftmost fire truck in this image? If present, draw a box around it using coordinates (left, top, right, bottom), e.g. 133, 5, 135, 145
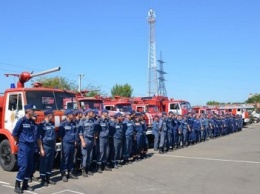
32, 76, 77, 91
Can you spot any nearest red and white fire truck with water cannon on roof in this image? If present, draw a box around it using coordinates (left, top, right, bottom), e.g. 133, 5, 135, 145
0, 67, 75, 171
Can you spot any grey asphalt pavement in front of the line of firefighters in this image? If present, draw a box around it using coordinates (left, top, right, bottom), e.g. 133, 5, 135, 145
0, 123, 260, 194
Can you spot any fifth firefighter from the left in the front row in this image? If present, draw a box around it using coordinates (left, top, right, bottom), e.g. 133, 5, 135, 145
97, 109, 111, 173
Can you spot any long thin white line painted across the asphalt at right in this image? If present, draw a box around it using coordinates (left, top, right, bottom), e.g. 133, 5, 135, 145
155, 154, 260, 164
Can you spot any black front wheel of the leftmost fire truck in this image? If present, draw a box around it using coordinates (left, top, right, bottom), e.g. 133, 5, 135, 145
0, 139, 17, 171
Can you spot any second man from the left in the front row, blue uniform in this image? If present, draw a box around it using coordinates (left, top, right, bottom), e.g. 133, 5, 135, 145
37, 109, 56, 186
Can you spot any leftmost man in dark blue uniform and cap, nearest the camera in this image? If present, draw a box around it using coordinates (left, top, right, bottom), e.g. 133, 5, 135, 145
12, 104, 36, 193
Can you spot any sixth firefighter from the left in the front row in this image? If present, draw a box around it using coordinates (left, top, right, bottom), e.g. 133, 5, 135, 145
111, 113, 124, 169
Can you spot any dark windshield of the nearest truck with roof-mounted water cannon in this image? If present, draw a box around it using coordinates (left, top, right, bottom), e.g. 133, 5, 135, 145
26, 91, 75, 110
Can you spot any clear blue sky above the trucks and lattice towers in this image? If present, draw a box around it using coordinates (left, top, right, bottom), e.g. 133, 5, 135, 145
0, 0, 260, 105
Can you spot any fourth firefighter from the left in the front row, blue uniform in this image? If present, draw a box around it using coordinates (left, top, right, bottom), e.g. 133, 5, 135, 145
79, 109, 95, 177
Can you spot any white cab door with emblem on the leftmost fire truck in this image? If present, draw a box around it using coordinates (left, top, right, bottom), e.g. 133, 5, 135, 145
4, 92, 24, 132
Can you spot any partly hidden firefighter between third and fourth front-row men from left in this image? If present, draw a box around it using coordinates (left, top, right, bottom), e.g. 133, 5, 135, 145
74, 110, 83, 173
